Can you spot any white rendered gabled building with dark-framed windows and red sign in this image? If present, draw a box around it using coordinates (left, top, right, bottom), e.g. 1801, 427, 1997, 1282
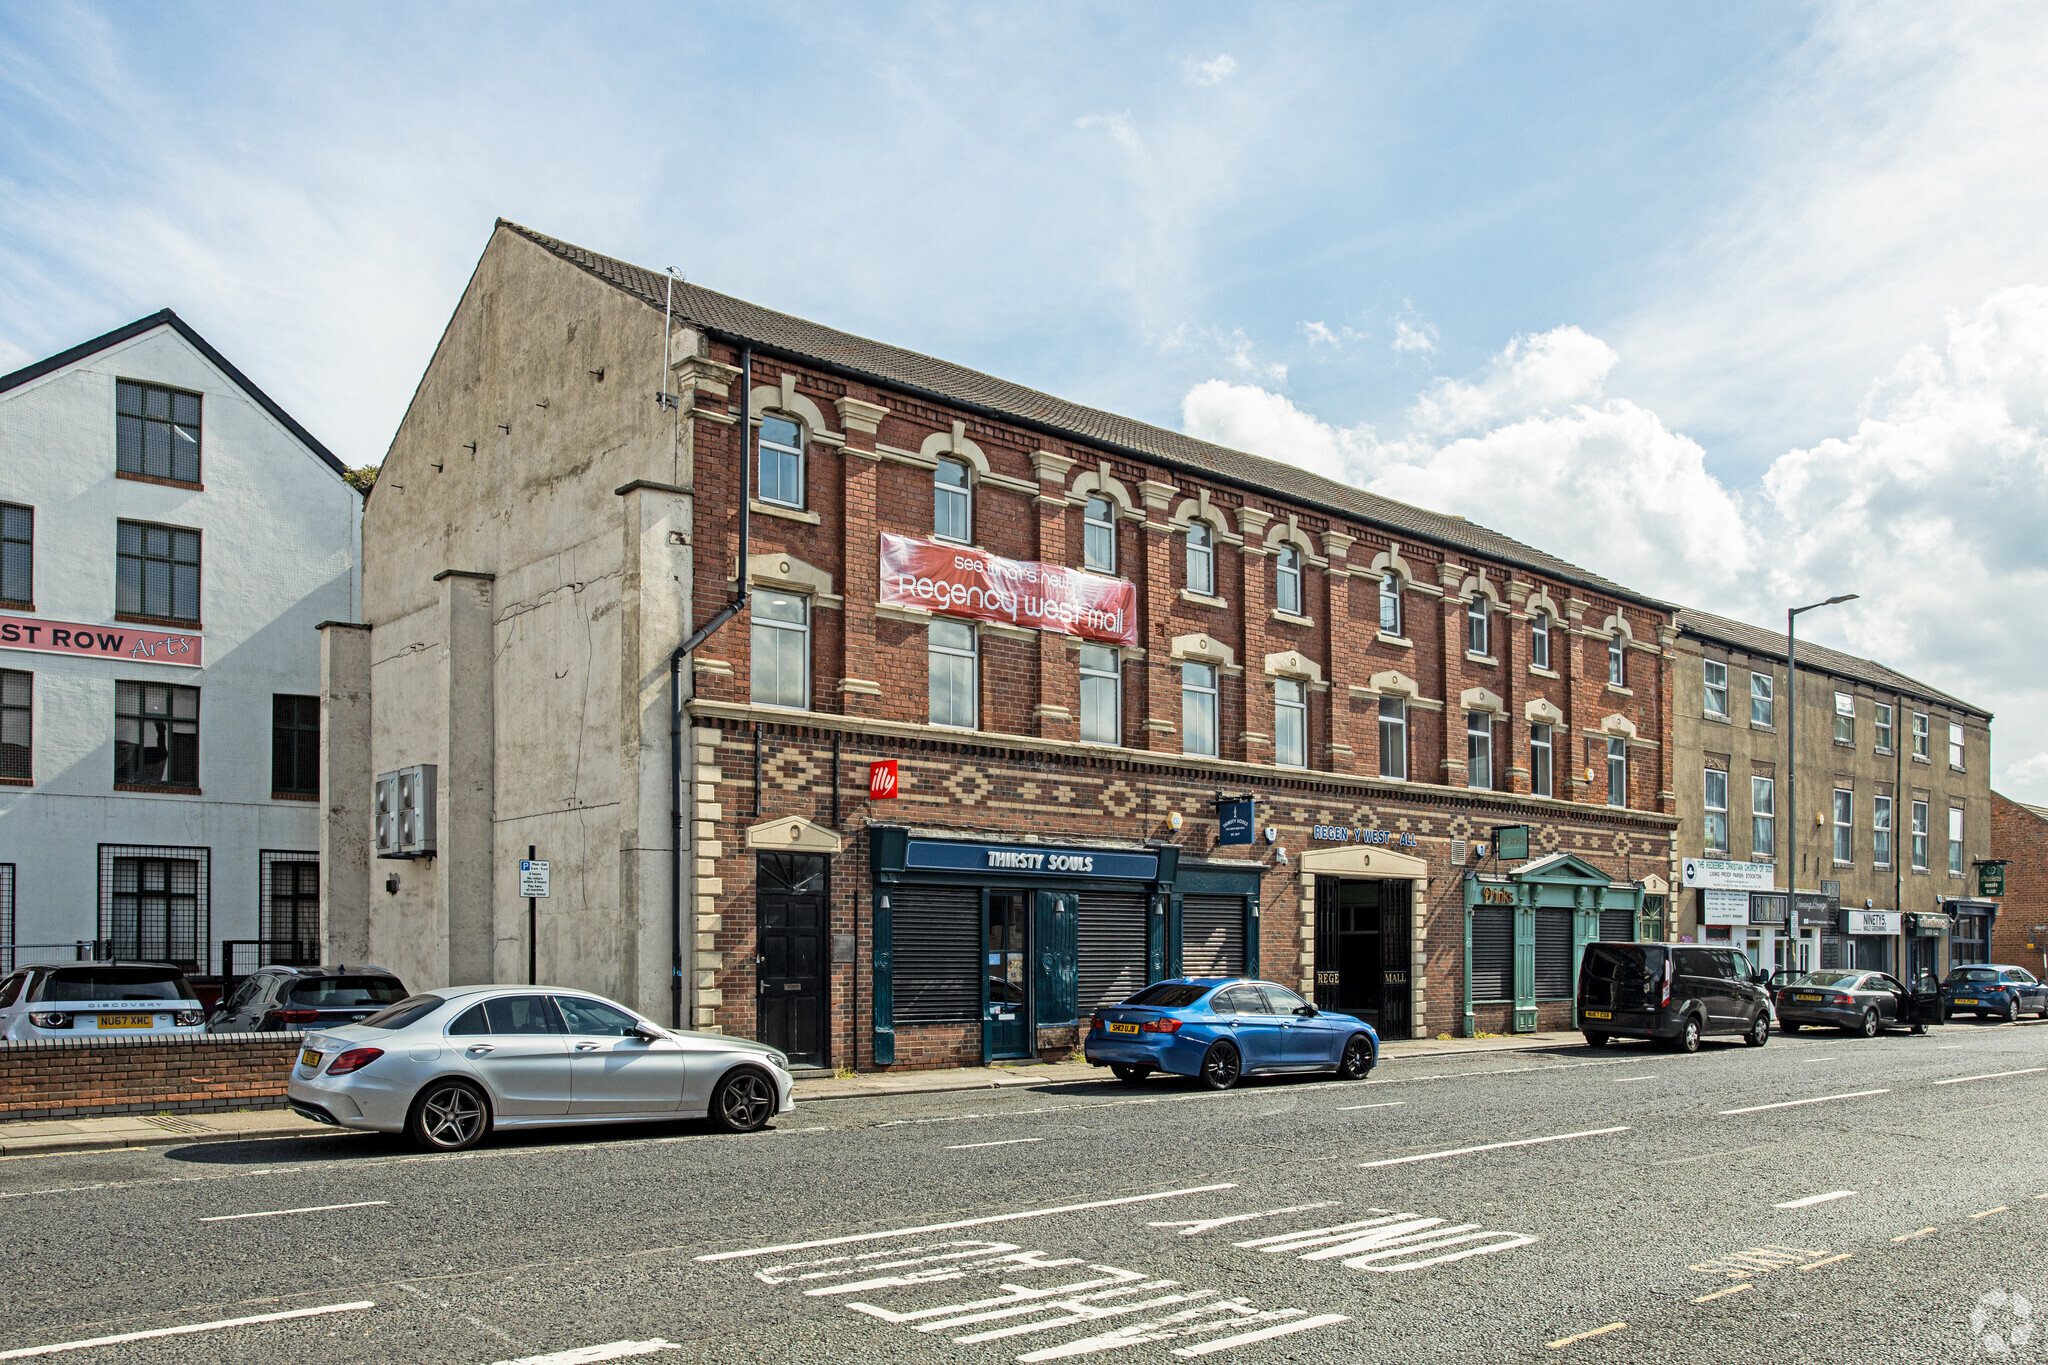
0, 309, 362, 974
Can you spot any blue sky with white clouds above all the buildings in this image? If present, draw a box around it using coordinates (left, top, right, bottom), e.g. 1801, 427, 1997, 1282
12, 0, 2048, 802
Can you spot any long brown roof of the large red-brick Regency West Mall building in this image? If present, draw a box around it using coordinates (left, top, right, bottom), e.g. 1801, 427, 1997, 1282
498, 219, 1671, 610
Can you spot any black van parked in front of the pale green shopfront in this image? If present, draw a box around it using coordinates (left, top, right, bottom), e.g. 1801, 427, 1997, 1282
1579, 943, 1772, 1052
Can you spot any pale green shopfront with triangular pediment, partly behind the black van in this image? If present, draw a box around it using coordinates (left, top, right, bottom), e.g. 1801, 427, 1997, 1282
1462, 853, 1665, 1038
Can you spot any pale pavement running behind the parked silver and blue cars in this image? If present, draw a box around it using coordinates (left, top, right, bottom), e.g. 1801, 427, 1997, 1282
0, 1033, 1579, 1156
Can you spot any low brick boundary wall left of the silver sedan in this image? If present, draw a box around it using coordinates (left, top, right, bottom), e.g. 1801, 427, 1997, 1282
0, 1031, 303, 1121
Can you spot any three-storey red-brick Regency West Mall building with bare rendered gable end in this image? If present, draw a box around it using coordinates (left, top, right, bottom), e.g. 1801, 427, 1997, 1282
328, 223, 1677, 1066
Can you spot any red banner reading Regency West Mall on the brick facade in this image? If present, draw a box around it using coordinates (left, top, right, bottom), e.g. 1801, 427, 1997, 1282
881, 532, 1139, 645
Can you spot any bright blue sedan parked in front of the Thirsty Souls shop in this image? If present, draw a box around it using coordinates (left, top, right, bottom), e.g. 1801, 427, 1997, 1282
1083, 976, 1380, 1091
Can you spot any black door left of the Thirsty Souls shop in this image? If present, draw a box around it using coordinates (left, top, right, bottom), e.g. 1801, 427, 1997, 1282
754, 853, 827, 1066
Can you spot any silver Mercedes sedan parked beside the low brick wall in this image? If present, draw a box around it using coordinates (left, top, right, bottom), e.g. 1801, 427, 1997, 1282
287, 986, 797, 1152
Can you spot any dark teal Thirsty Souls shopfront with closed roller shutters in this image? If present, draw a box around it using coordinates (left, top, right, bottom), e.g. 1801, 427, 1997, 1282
868, 825, 1264, 1066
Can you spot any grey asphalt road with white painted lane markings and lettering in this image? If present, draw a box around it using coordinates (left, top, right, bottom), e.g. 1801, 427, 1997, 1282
0, 1021, 2048, 1365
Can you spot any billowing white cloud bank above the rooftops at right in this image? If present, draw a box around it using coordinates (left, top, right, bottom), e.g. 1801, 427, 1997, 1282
1182, 294, 2048, 800
